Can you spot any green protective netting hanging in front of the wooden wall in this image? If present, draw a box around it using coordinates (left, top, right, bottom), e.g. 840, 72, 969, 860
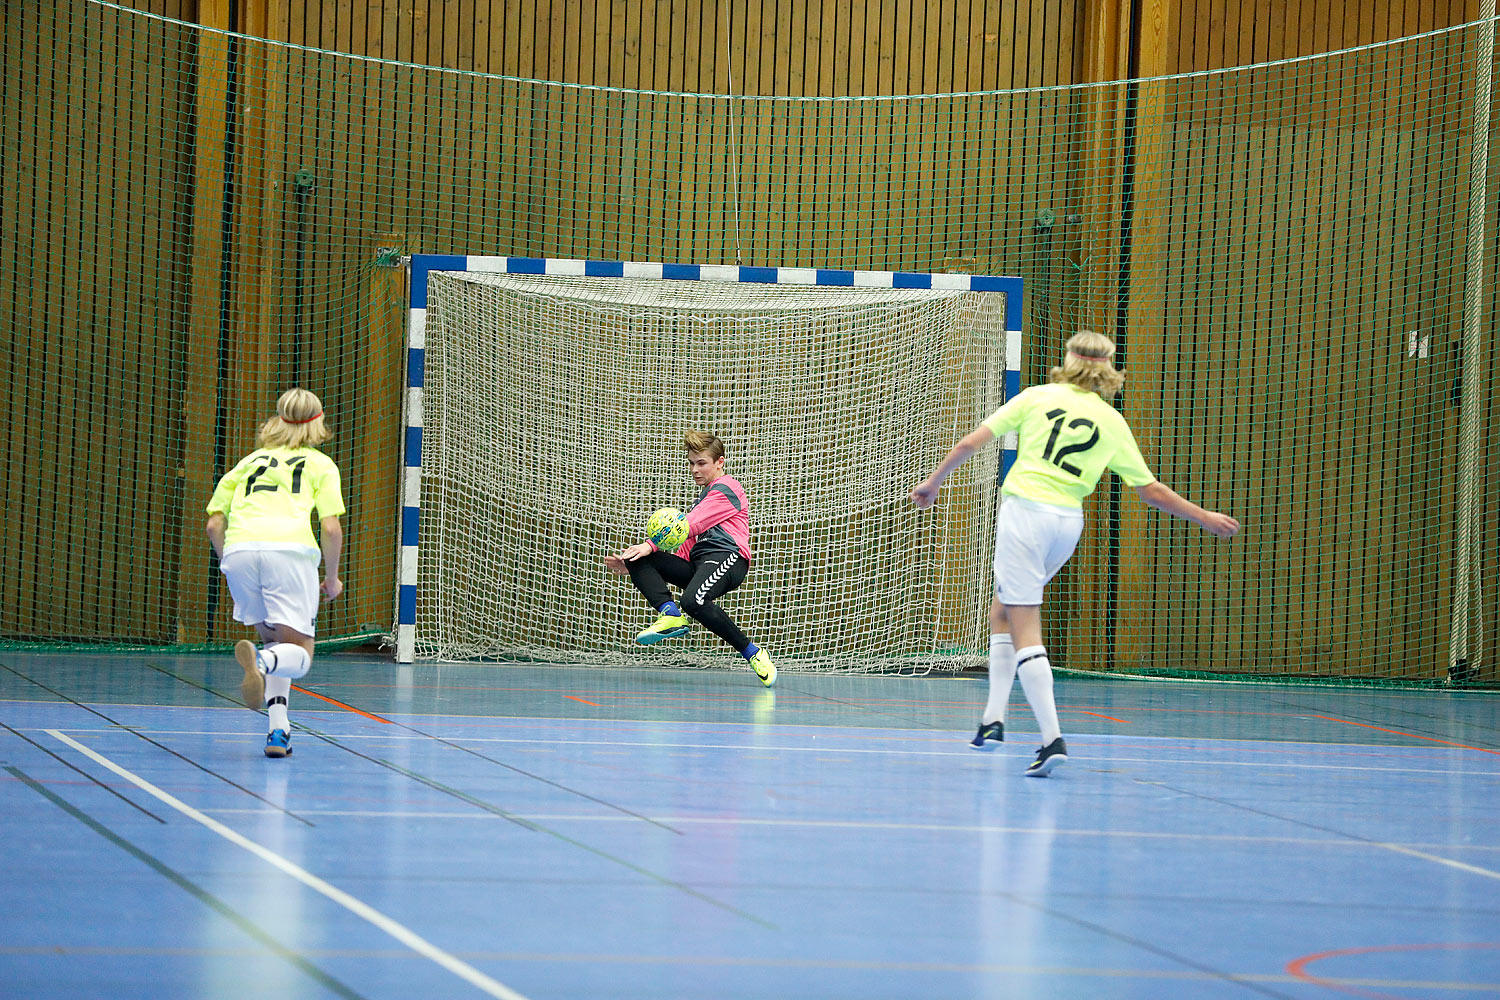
0, 0, 1500, 684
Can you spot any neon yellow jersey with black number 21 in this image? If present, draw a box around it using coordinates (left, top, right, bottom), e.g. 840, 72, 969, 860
209, 448, 344, 549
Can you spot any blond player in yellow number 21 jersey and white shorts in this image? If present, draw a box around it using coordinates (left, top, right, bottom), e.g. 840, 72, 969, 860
207, 388, 344, 757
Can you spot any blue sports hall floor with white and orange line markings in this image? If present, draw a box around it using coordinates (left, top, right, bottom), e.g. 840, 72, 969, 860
0, 652, 1500, 1000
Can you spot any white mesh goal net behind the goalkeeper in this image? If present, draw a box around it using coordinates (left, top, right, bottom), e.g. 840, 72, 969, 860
401, 258, 1020, 672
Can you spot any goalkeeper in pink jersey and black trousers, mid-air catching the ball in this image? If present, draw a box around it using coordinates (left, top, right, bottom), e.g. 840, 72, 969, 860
605, 430, 776, 687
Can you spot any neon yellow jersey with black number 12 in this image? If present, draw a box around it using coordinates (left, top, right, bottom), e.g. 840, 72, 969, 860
981, 382, 1157, 508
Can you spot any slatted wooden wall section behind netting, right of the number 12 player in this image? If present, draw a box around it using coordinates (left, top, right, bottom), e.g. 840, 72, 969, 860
1118, 21, 1473, 679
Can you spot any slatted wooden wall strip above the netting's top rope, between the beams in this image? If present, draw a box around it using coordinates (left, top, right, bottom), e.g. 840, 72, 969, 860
270, 0, 1083, 96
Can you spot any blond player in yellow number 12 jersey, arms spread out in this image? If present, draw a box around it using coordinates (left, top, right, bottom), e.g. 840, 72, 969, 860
912, 330, 1239, 778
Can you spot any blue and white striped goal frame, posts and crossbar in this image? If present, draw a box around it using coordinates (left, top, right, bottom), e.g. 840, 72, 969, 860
396, 253, 1023, 663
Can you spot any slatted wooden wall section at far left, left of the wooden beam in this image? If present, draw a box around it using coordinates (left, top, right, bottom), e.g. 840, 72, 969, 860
0, 4, 191, 642
